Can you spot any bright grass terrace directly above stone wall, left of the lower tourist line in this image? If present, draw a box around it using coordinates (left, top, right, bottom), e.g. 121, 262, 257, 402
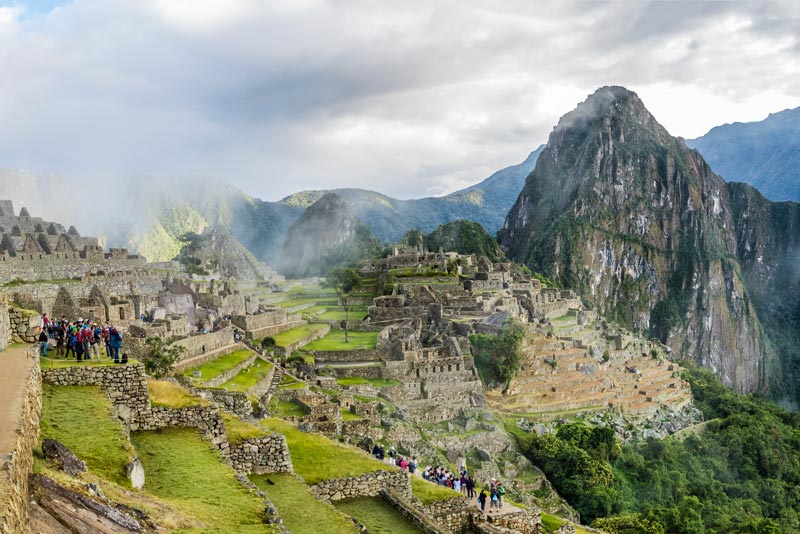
262, 418, 388, 485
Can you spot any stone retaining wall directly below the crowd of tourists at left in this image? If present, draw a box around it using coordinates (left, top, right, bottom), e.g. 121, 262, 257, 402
42, 363, 150, 423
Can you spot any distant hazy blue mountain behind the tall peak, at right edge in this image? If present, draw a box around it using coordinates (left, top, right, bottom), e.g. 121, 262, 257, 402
686, 108, 800, 200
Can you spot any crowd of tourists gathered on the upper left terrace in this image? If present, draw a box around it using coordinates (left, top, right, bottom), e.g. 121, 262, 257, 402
39, 313, 127, 363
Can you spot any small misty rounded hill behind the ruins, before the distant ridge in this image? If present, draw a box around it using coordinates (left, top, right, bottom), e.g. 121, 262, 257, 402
279, 193, 378, 278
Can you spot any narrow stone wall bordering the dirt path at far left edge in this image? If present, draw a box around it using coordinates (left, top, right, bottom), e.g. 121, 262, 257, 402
0, 358, 42, 534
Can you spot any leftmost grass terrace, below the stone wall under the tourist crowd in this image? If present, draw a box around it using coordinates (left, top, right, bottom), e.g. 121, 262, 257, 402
41, 384, 135, 488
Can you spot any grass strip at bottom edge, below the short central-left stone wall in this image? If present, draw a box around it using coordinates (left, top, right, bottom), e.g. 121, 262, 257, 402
250, 473, 358, 534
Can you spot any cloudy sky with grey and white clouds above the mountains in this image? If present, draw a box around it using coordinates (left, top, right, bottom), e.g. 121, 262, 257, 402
0, 0, 800, 200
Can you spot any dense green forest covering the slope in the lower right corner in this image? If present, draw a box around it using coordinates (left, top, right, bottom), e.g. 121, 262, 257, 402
516, 369, 800, 534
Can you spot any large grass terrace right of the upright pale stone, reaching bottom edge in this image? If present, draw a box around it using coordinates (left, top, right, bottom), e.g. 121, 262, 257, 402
131, 428, 274, 533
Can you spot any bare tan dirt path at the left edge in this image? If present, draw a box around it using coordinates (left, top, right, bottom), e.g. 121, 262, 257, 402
0, 345, 37, 457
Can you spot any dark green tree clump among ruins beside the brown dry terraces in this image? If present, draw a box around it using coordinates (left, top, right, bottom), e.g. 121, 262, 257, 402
469, 322, 525, 386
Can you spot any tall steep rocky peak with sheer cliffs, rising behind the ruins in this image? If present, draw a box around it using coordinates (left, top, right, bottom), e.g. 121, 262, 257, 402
500, 87, 800, 402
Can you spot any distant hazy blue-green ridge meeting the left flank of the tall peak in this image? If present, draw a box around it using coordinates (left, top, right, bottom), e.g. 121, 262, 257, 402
280, 146, 543, 242
